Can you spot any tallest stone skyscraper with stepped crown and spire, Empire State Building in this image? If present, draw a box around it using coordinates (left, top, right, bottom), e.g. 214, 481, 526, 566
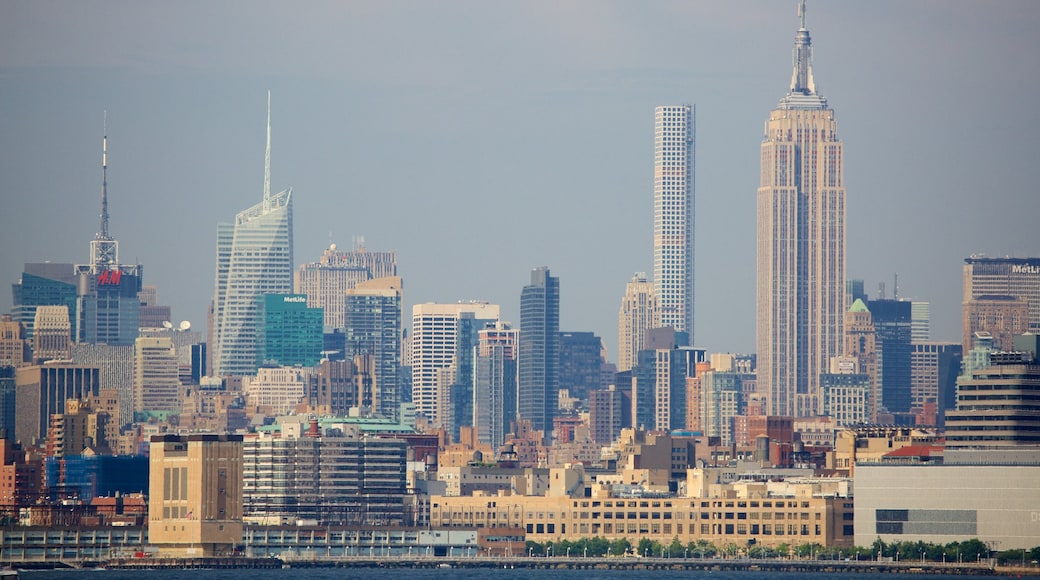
756, 5, 846, 417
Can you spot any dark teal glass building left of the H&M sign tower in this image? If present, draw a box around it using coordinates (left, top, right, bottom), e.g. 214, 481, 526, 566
10, 262, 76, 340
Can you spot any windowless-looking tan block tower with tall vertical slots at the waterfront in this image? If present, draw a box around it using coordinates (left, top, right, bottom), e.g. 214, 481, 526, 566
148, 433, 243, 557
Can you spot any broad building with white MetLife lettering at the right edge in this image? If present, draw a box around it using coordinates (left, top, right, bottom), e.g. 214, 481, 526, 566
962, 256, 1040, 352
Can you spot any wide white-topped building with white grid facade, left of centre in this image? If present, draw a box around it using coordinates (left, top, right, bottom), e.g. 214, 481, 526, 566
412, 301, 500, 432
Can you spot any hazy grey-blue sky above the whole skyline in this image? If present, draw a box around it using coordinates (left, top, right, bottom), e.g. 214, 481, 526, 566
0, 0, 1040, 361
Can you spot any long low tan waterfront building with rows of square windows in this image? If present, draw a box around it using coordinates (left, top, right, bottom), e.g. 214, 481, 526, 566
431, 480, 848, 547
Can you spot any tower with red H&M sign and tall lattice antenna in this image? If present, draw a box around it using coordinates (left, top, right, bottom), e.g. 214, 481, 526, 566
70, 116, 142, 345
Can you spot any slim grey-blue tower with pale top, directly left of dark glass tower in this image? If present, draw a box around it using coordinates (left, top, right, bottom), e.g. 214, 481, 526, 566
473, 322, 519, 450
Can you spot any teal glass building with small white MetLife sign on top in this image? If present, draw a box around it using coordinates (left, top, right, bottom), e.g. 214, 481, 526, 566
257, 294, 324, 367
